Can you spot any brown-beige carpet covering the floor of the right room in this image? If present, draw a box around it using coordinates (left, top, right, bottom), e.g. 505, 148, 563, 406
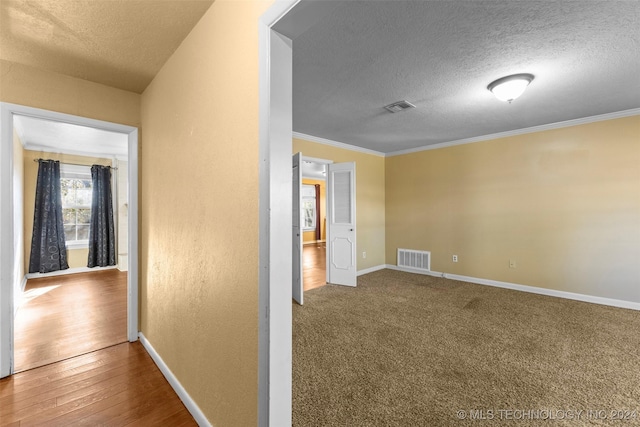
293, 270, 640, 426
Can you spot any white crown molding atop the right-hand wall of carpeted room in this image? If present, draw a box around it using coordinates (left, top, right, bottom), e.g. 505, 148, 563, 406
385, 108, 640, 157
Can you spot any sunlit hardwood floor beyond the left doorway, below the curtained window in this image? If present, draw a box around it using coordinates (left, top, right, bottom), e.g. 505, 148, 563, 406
14, 269, 127, 372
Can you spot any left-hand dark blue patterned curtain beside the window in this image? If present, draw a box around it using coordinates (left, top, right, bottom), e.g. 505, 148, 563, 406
29, 159, 69, 273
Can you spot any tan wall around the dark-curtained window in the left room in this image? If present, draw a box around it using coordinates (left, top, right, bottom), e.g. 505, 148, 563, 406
24, 150, 111, 272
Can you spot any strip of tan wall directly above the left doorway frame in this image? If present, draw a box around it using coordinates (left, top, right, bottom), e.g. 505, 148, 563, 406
0, 60, 140, 126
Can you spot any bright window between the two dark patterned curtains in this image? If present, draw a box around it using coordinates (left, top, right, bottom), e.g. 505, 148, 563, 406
60, 164, 93, 247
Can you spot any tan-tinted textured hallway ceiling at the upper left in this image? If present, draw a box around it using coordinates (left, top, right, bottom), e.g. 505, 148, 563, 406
0, 0, 213, 93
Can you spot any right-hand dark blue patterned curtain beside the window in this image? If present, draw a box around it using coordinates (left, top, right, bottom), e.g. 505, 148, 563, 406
87, 165, 116, 267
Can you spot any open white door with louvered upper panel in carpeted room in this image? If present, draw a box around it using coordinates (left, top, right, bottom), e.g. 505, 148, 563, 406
327, 162, 356, 286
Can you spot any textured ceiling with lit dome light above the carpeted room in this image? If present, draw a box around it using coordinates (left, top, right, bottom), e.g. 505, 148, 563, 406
293, 0, 640, 153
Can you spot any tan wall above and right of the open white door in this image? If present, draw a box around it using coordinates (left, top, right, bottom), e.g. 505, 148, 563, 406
293, 138, 385, 270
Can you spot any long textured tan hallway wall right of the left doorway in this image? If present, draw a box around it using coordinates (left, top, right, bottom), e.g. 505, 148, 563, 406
140, 1, 271, 426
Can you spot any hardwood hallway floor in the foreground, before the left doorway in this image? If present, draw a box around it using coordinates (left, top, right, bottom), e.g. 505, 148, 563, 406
0, 342, 197, 427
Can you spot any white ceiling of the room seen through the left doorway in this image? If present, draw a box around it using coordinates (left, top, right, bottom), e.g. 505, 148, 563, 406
13, 114, 129, 159
